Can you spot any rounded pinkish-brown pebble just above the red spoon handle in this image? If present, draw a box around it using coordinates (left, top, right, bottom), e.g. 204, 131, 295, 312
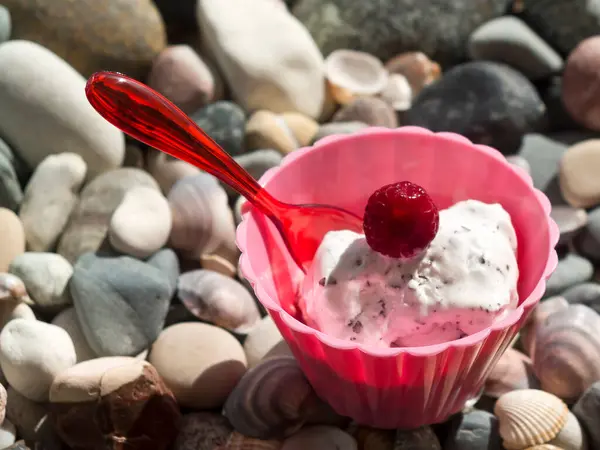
148, 44, 215, 114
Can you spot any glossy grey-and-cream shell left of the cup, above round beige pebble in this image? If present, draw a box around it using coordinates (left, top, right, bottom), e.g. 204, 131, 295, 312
177, 270, 260, 334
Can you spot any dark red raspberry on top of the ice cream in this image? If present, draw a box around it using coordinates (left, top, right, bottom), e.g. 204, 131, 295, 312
363, 181, 439, 258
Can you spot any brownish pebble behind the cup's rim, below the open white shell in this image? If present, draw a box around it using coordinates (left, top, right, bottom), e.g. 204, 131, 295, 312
332, 97, 398, 128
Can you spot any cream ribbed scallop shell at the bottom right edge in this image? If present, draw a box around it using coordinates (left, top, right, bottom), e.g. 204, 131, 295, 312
494, 389, 569, 450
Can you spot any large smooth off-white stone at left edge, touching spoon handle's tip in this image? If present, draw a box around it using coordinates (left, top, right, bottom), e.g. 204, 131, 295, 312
0, 40, 125, 176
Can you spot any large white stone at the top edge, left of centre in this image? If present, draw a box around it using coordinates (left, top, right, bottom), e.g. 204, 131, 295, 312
196, 0, 325, 119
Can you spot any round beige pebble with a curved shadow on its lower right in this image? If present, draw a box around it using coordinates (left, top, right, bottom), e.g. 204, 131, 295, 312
148, 322, 247, 409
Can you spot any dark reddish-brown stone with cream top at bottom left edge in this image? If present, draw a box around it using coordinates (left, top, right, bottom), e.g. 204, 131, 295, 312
50, 357, 181, 450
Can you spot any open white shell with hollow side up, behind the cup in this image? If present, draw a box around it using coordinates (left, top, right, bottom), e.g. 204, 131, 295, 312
324, 49, 388, 105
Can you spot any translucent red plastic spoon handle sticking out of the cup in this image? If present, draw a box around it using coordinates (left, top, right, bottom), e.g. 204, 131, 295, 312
85, 72, 281, 218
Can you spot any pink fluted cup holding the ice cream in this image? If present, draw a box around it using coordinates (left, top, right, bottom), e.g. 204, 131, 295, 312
237, 127, 558, 428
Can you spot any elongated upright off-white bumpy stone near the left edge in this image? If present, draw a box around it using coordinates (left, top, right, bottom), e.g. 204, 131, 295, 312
19, 153, 87, 252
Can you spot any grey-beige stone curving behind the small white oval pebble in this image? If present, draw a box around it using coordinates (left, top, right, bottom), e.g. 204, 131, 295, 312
57, 167, 159, 264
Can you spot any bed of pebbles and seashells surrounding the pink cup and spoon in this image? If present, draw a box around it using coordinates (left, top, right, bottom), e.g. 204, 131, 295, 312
0, 0, 600, 450
